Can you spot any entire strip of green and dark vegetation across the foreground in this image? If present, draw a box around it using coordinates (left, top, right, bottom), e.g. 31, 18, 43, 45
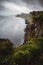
0, 37, 43, 65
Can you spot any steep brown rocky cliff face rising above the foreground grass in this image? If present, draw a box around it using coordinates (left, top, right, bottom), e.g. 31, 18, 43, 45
24, 11, 43, 43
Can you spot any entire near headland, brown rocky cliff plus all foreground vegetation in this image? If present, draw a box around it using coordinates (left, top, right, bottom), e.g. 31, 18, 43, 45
0, 12, 43, 65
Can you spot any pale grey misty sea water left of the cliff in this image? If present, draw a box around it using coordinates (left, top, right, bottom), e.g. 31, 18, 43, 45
0, 16, 26, 46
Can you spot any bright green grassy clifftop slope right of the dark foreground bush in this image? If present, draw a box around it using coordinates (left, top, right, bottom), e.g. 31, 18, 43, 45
14, 38, 43, 65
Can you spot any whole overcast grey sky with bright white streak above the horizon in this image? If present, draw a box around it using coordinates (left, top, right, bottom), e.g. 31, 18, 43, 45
0, 0, 43, 15
